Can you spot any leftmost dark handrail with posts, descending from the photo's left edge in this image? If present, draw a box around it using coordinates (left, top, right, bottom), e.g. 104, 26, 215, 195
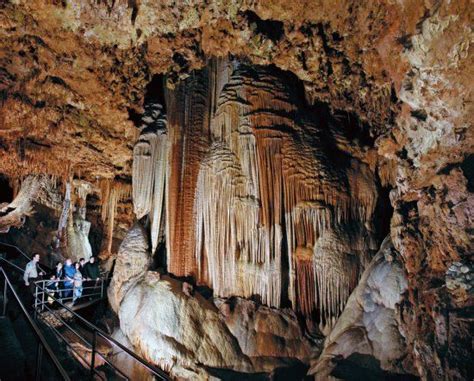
0, 266, 71, 380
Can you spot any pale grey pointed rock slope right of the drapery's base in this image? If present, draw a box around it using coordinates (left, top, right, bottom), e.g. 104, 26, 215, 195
309, 237, 414, 380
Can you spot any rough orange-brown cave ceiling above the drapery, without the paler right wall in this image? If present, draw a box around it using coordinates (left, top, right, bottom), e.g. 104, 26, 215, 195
0, 1, 460, 179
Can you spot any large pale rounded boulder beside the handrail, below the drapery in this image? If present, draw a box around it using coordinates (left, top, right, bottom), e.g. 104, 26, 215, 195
117, 272, 252, 379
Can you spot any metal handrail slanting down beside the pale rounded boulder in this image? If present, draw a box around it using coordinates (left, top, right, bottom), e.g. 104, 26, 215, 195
34, 280, 169, 380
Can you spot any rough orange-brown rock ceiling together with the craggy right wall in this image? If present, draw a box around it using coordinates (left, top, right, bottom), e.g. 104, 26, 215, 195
0, 0, 474, 379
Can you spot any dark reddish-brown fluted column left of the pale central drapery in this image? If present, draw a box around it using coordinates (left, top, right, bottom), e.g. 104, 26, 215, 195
166, 60, 229, 276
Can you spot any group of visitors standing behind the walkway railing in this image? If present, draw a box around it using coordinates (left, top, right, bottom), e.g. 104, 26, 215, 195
23, 254, 100, 304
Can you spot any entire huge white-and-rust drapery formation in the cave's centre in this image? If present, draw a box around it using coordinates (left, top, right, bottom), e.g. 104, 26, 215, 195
133, 61, 377, 325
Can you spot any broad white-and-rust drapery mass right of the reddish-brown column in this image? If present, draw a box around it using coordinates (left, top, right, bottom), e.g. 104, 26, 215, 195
191, 61, 376, 324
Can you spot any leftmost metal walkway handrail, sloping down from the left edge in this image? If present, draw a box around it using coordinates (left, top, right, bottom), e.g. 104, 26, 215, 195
0, 266, 70, 381
